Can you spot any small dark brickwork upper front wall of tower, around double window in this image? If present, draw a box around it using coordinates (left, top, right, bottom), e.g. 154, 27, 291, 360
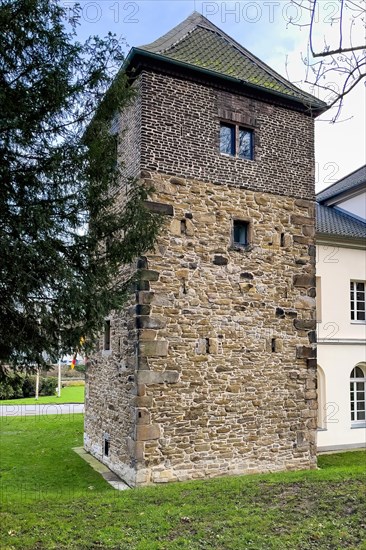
141, 72, 314, 199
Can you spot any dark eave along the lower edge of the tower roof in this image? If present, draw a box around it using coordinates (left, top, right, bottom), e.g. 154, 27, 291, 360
123, 48, 329, 116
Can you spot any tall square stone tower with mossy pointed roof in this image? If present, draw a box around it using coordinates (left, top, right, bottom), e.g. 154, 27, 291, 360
85, 13, 326, 486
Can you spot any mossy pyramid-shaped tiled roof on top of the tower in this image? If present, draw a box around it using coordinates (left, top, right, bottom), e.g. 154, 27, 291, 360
136, 12, 326, 110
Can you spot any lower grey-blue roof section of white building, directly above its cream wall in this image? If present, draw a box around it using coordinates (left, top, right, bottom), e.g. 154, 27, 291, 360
316, 204, 366, 239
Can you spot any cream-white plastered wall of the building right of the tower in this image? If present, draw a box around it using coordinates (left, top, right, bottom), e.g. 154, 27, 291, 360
317, 245, 366, 450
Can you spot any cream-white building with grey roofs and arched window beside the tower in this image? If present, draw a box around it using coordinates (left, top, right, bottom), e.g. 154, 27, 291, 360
316, 166, 366, 451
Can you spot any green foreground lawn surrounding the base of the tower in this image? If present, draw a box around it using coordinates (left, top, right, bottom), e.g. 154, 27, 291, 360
0, 415, 366, 550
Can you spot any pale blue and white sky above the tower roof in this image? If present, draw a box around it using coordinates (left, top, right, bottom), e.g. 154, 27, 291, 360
67, 0, 366, 191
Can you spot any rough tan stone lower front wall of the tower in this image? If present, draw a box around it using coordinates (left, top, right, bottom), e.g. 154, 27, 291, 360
132, 172, 317, 484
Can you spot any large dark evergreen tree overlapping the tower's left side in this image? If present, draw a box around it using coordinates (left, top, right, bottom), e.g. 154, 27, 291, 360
0, 0, 161, 374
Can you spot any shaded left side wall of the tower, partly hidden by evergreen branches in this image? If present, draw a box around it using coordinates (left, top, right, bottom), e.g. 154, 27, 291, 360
84, 79, 141, 485
